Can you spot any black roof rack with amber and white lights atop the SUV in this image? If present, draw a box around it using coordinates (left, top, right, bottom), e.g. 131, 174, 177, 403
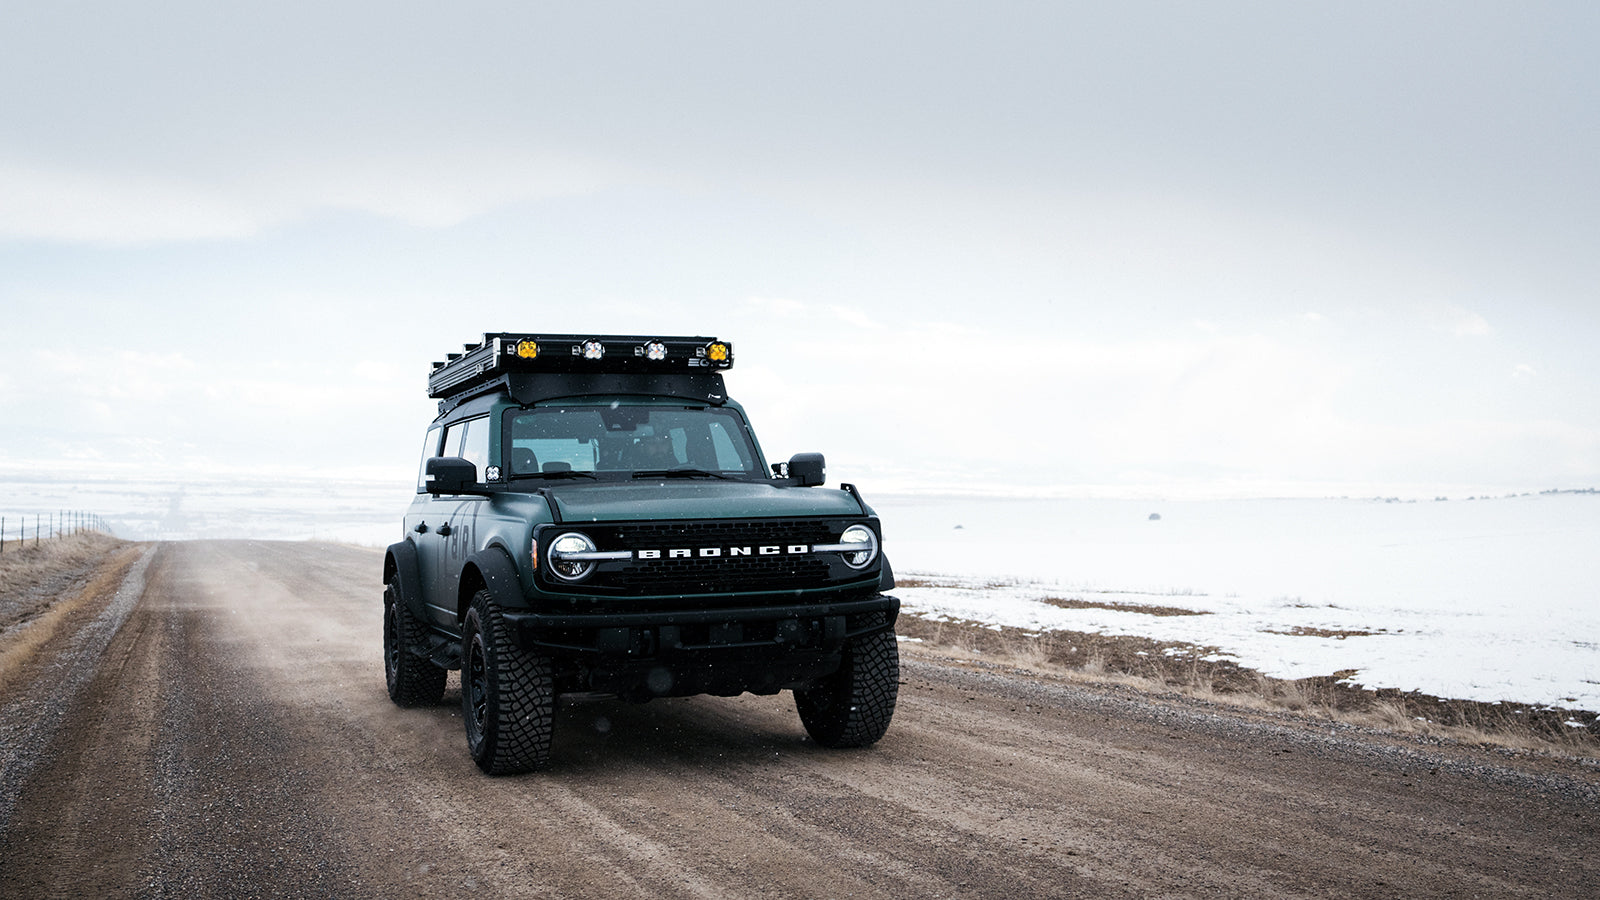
427, 331, 733, 412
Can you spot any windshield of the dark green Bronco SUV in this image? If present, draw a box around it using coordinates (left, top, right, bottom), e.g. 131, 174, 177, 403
509, 405, 763, 477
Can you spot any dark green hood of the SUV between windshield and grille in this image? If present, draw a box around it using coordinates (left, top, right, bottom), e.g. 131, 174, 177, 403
549, 479, 869, 522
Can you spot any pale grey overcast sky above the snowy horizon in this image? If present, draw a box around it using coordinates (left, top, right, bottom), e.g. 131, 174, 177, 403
0, 0, 1600, 495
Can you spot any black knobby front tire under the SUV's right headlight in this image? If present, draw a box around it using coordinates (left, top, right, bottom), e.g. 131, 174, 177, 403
795, 614, 899, 748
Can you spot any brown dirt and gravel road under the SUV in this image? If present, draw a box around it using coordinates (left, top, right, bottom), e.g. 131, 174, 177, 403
0, 541, 1600, 898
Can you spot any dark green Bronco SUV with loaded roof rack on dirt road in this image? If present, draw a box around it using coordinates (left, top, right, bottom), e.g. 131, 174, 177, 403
384, 333, 899, 775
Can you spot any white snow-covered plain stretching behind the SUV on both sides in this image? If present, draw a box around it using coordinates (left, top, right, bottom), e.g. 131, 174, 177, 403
0, 471, 1600, 711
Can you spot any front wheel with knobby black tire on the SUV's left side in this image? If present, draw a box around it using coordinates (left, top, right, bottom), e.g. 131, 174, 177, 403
461, 591, 555, 775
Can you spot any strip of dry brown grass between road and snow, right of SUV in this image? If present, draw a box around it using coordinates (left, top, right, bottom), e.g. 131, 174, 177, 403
896, 613, 1600, 757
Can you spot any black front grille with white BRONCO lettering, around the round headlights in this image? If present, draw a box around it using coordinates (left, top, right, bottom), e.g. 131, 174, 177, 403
542, 517, 877, 596
